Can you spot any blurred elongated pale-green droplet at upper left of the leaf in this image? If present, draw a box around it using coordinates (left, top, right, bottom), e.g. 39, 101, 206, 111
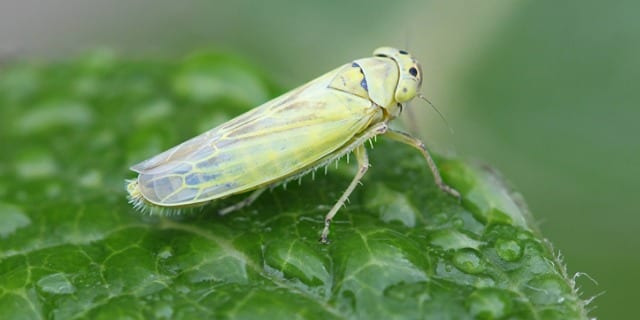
16, 102, 93, 134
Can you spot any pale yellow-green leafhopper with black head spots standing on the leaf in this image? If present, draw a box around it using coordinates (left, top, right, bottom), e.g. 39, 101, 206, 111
126, 47, 460, 243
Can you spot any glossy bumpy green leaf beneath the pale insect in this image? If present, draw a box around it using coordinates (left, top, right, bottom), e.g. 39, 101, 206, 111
0, 48, 586, 319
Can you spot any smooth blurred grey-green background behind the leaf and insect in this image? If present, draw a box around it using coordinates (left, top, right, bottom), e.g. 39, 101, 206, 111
0, 0, 640, 319
